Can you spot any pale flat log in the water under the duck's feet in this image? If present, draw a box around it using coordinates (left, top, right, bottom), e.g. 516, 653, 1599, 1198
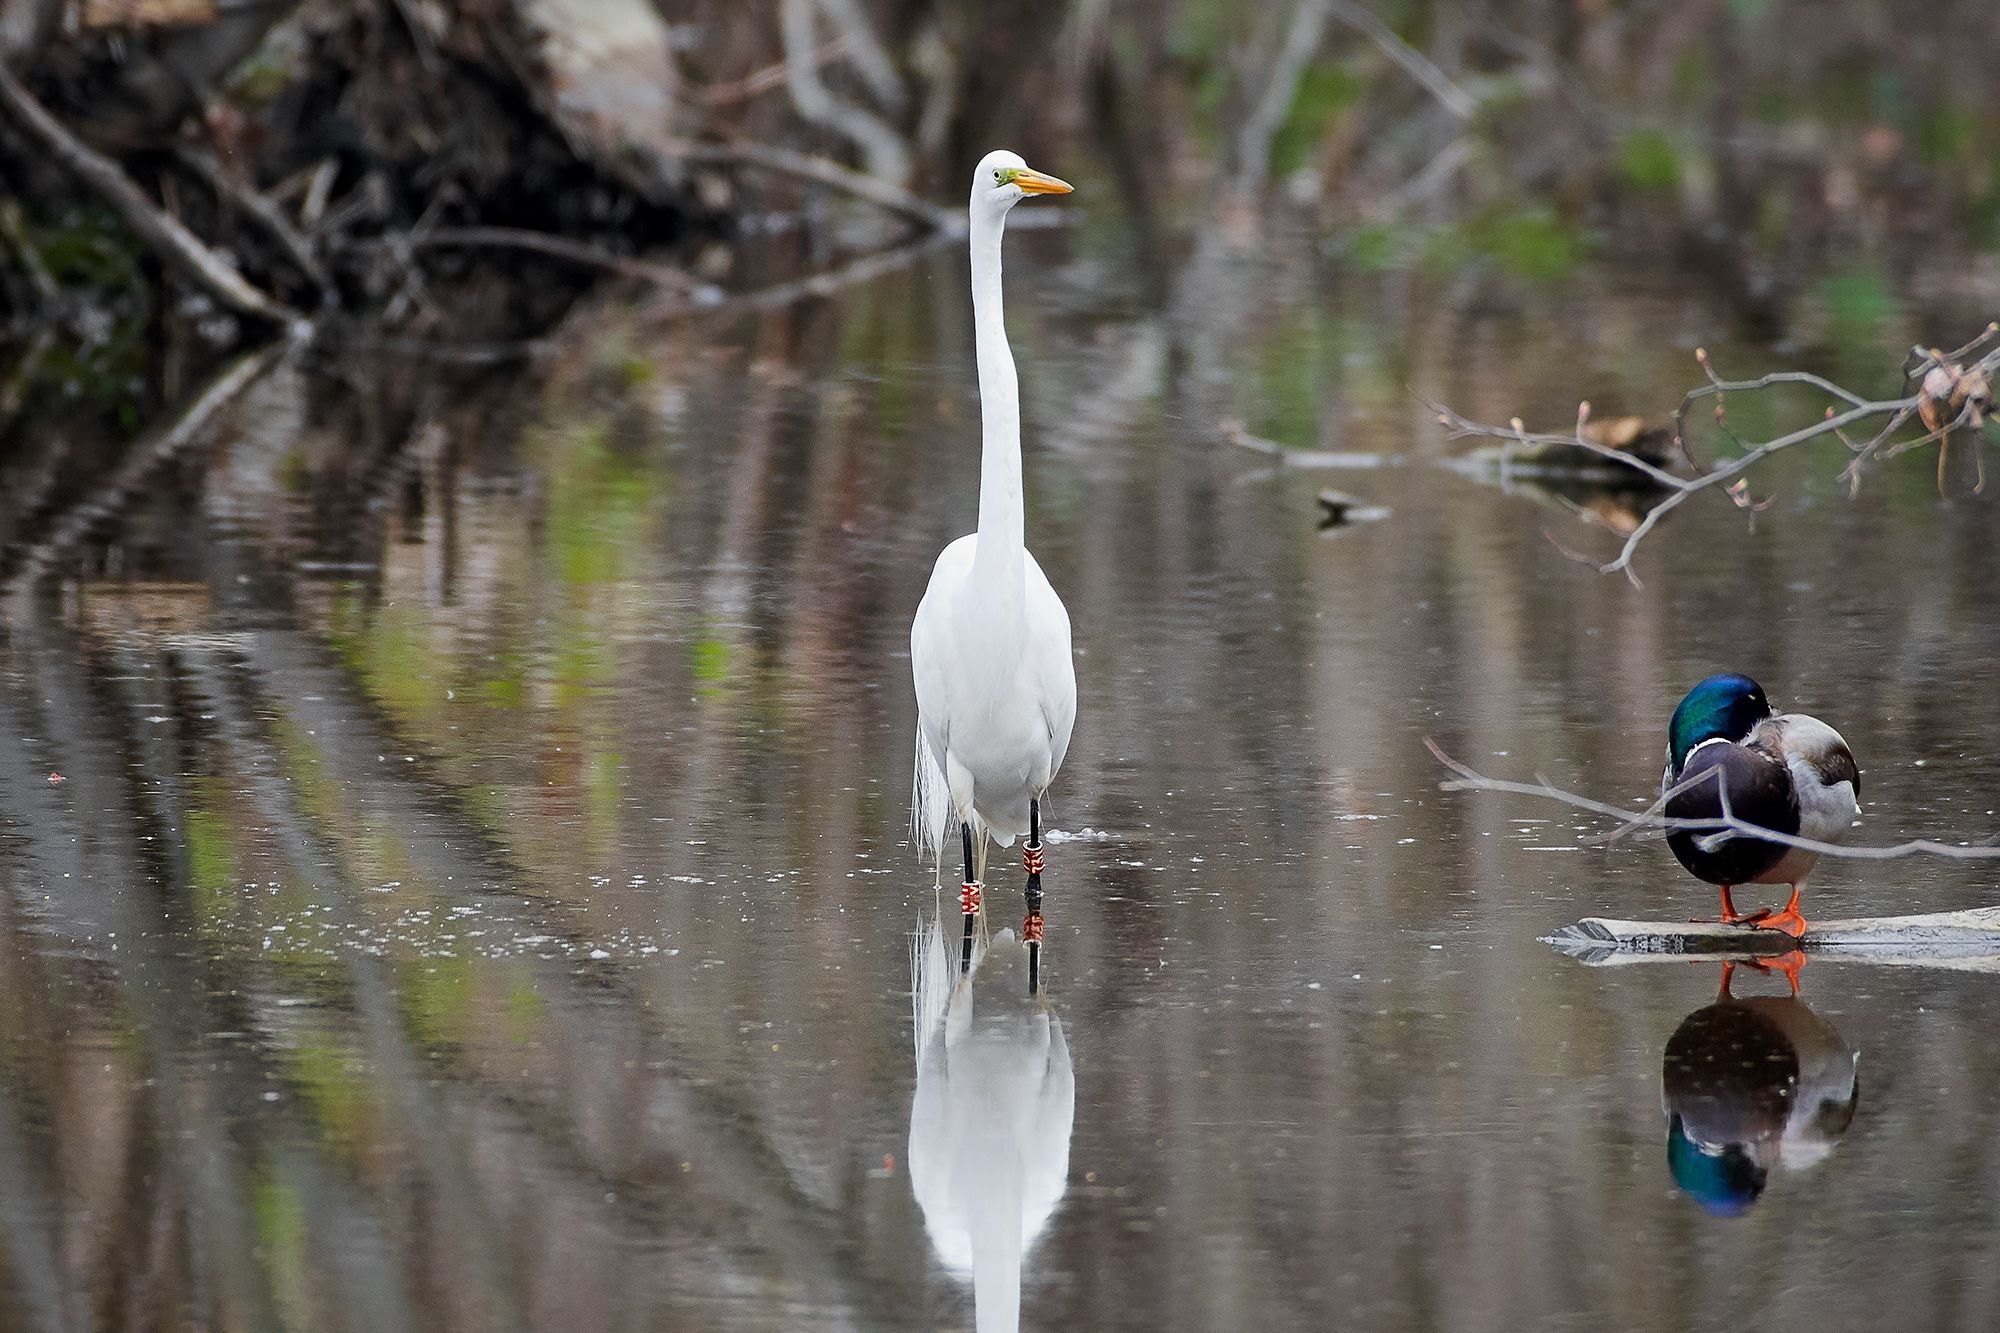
1542, 907, 2000, 971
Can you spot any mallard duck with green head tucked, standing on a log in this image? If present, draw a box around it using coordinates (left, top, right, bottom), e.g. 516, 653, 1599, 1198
1660, 673, 1862, 937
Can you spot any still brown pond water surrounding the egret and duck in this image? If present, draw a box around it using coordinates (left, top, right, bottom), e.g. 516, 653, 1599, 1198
0, 220, 2000, 1331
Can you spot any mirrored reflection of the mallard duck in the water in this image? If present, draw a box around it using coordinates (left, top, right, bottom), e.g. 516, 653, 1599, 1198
1660, 951, 1860, 1217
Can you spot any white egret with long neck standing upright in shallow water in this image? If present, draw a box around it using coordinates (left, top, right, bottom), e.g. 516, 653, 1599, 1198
910, 152, 1076, 989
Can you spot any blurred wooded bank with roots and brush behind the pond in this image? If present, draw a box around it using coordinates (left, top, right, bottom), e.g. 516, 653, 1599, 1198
0, 0, 2000, 344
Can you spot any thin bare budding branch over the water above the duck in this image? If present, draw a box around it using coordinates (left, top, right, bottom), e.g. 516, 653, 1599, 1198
1424, 324, 2000, 584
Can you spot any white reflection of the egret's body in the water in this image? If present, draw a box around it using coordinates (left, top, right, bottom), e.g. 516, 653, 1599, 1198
910, 921, 1076, 1333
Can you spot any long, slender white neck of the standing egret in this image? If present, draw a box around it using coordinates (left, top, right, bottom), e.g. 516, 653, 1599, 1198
972, 200, 1026, 596
